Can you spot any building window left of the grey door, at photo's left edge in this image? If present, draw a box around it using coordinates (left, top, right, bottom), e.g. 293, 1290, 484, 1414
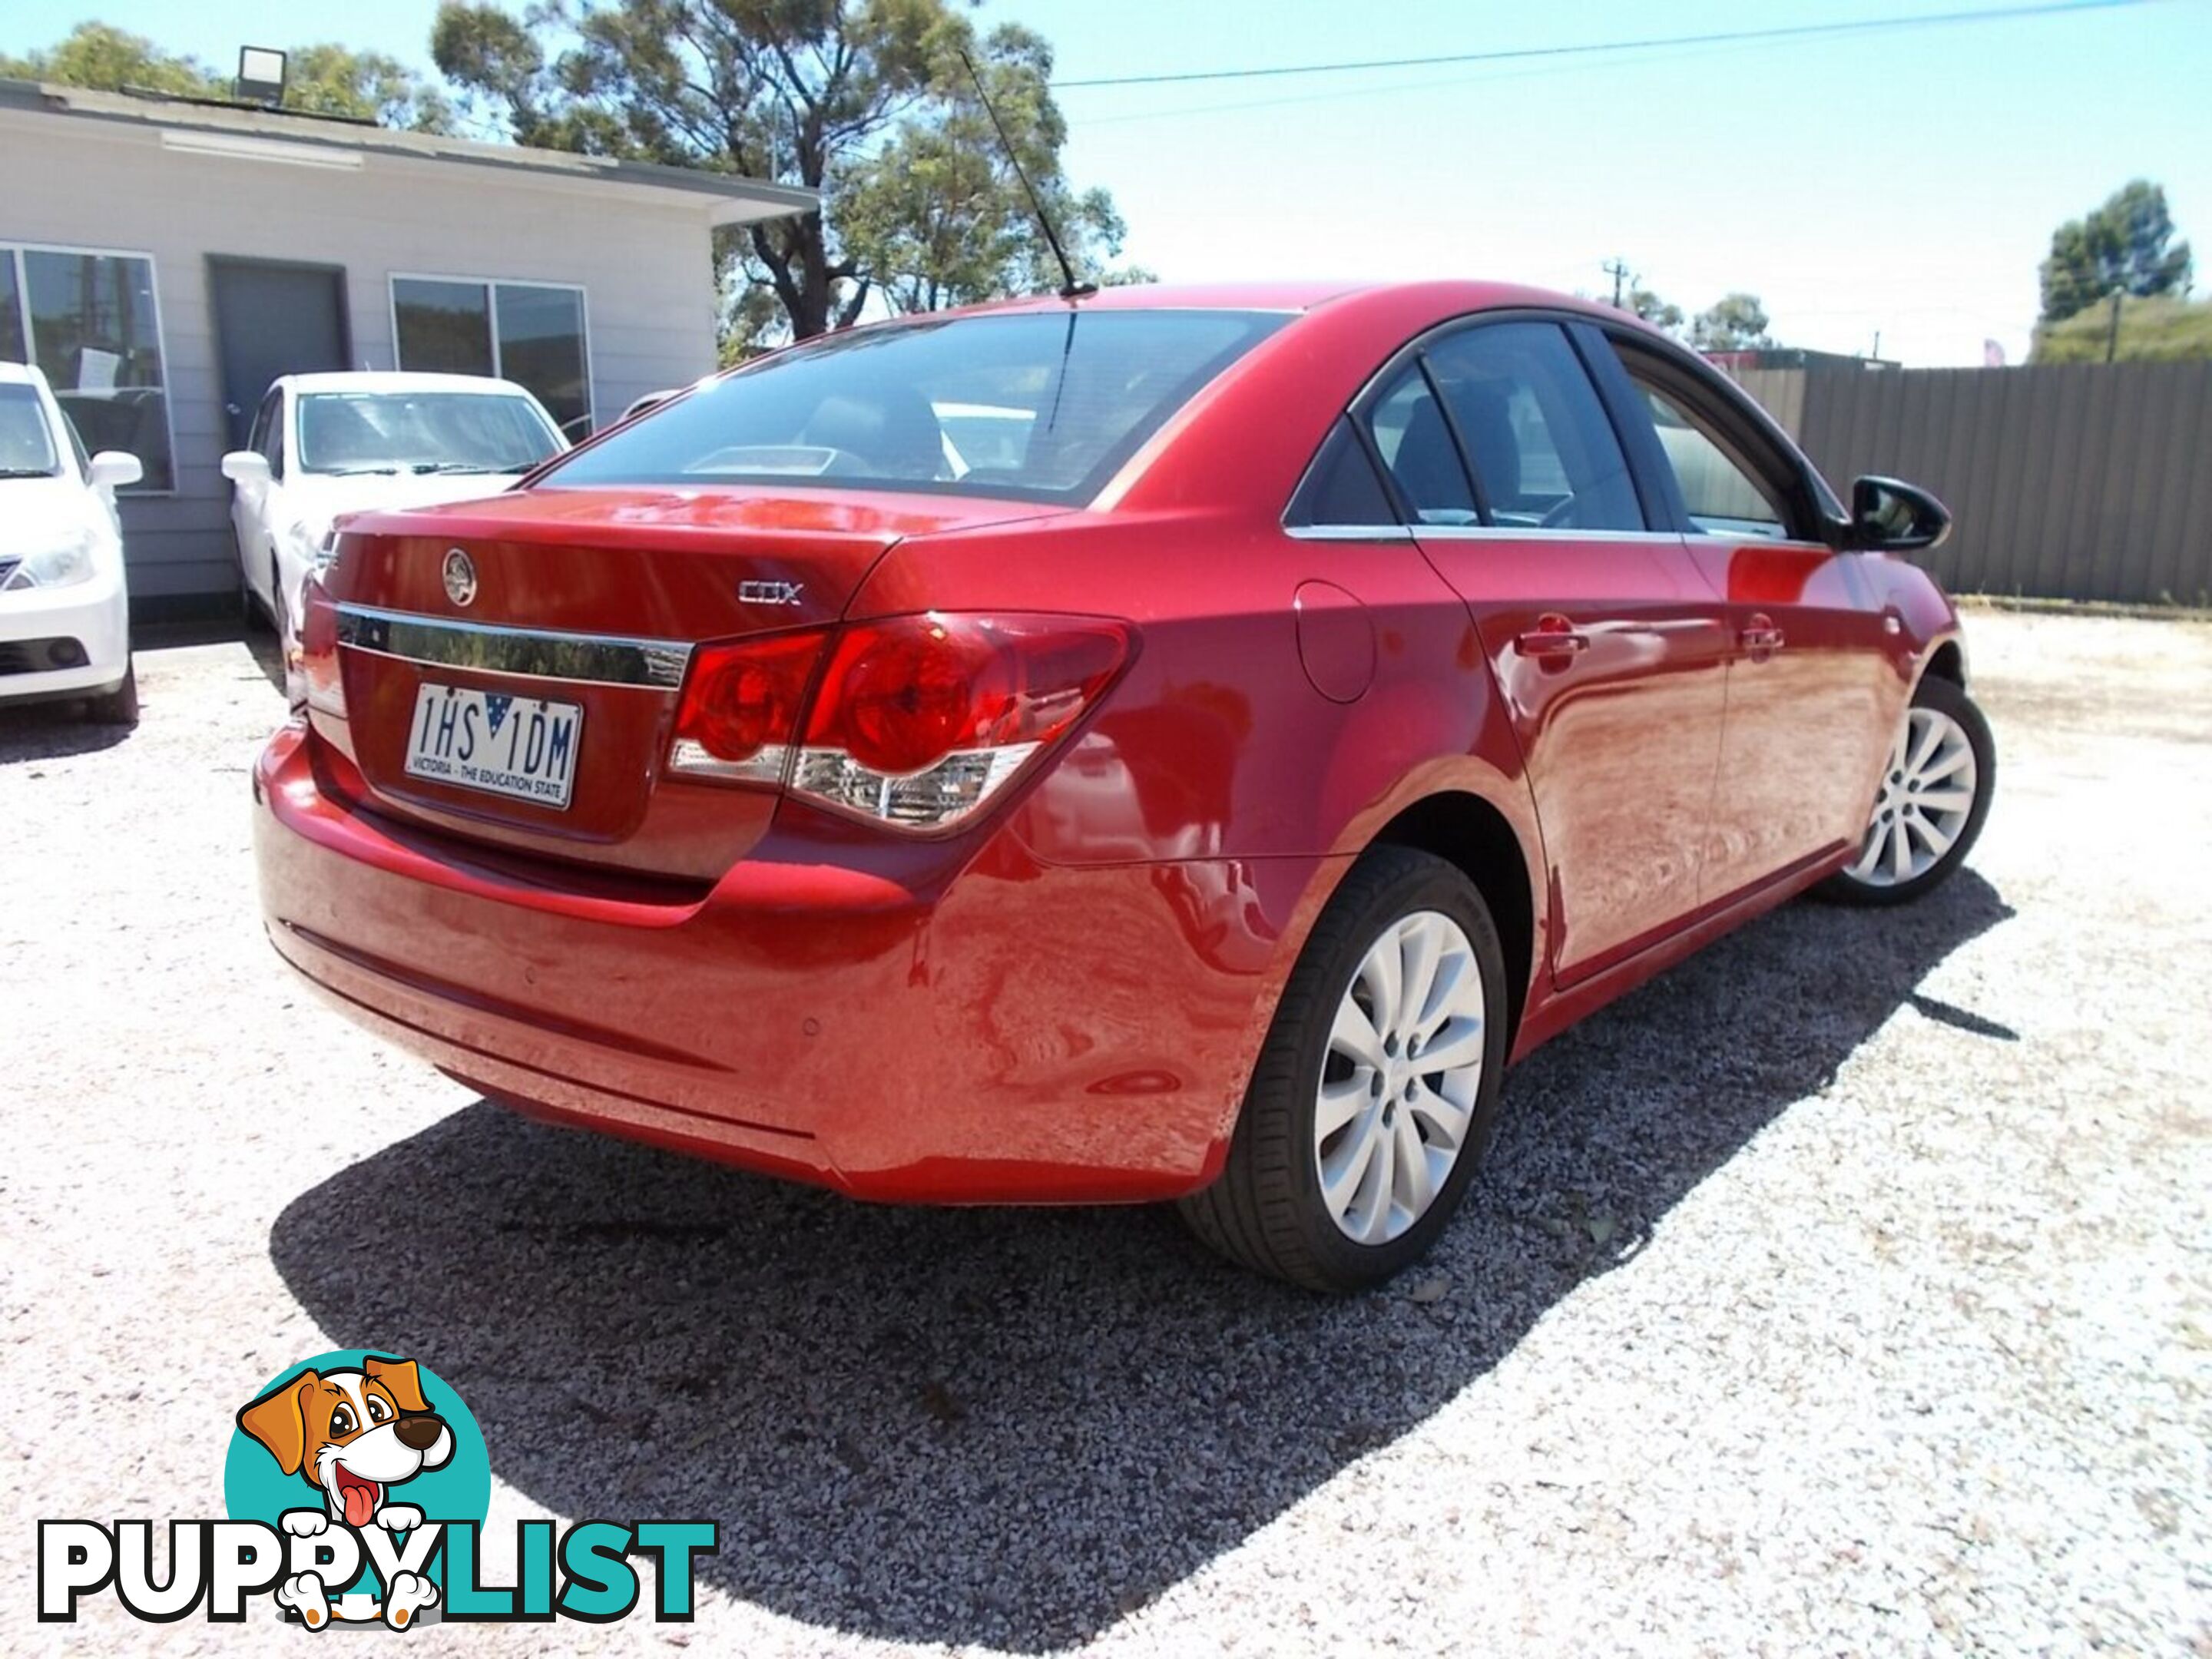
0, 243, 177, 493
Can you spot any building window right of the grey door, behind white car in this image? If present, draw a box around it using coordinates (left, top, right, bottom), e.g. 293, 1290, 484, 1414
392, 276, 591, 435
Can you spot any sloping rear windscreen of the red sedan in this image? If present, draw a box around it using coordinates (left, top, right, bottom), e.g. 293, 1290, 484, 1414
538, 310, 1290, 500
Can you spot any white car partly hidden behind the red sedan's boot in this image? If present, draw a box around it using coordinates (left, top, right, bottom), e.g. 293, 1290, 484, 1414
224, 374, 568, 644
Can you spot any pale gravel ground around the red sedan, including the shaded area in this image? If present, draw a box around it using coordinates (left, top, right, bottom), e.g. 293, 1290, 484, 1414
0, 613, 2212, 1654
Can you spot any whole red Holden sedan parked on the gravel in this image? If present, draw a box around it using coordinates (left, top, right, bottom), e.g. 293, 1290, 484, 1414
254, 283, 1995, 1290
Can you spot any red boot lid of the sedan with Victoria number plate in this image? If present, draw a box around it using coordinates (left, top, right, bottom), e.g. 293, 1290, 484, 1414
314, 488, 1060, 880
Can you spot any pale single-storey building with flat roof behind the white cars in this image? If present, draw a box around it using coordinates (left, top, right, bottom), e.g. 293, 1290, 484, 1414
0, 80, 816, 615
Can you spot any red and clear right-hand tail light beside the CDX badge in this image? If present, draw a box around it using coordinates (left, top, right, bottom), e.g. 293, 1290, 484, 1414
668, 615, 1131, 830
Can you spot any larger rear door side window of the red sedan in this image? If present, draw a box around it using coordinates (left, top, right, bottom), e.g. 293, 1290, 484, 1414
1427, 323, 1644, 531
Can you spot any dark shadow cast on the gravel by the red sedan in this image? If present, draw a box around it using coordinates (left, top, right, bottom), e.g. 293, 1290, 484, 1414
272, 872, 2011, 1650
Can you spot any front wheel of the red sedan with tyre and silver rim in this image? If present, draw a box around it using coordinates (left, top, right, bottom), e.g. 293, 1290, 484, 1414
1814, 674, 1998, 905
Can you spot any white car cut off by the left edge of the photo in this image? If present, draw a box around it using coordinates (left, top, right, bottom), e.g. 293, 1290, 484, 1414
0, 363, 144, 726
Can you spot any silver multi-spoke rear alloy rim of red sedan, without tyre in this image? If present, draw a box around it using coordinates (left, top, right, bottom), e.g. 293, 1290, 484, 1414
1314, 909, 1486, 1245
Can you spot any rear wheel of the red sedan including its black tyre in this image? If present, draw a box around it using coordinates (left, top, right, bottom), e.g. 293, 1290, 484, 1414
1179, 847, 1506, 1292
